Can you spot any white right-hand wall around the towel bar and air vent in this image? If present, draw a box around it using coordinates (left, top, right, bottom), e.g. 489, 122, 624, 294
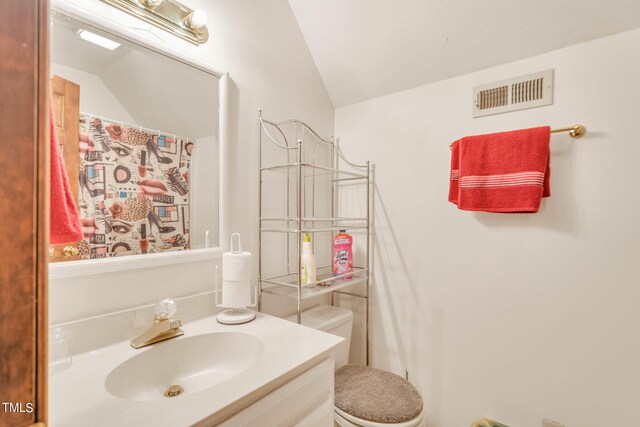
336, 30, 640, 427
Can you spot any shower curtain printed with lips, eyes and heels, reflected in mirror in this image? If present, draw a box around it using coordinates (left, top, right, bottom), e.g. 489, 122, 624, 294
78, 114, 193, 259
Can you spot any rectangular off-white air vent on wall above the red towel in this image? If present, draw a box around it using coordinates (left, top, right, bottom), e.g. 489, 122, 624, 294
473, 70, 553, 117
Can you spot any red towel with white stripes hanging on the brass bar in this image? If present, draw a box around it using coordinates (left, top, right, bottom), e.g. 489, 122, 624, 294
449, 126, 551, 213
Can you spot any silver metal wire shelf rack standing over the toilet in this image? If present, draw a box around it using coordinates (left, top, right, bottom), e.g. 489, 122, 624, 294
258, 110, 371, 365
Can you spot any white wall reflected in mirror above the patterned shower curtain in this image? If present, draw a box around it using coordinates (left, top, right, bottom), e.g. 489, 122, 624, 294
51, 62, 137, 125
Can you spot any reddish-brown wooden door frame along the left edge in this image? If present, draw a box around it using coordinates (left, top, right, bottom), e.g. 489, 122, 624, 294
0, 0, 49, 425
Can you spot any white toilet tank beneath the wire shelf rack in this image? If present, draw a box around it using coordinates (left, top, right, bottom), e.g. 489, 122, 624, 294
286, 305, 353, 369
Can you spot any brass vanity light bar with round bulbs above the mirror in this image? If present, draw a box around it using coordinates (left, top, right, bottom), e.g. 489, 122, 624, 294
102, 0, 209, 45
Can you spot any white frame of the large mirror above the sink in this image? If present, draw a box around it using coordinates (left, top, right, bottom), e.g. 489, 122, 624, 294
49, 0, 229, 279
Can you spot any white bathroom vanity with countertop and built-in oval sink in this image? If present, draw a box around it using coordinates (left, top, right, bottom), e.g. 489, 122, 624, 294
49, 313, 343, 427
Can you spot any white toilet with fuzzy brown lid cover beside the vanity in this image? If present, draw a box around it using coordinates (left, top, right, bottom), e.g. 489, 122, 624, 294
287, 305, 423, 427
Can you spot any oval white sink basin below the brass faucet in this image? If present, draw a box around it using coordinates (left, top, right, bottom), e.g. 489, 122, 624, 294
105, 332, 264, 401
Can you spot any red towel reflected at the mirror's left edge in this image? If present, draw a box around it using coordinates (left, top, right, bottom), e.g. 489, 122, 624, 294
49, 99, 83, 244
